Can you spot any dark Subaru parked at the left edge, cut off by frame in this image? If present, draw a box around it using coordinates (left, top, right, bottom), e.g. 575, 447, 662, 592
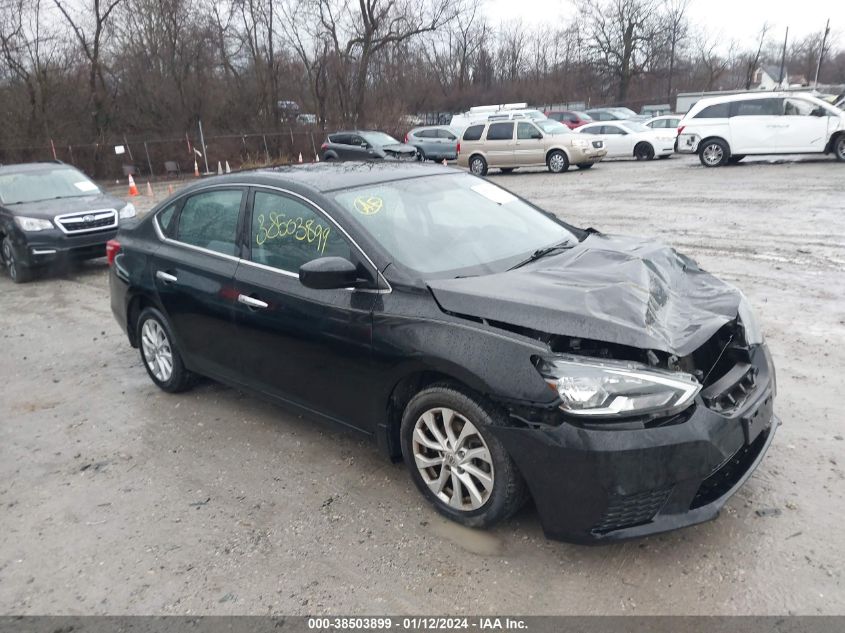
0, 161, 135, 283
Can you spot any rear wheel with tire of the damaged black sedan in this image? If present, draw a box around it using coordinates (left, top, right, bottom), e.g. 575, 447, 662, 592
136, 308, 194, 393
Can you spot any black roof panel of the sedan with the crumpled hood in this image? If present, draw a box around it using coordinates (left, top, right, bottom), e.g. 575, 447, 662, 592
210, 160, 458, 192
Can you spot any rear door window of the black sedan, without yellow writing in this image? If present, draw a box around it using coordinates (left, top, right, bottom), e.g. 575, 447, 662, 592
176, 189, 243, 256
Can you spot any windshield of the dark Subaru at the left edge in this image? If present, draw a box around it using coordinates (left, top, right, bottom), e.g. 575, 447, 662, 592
0, 165, 100, 204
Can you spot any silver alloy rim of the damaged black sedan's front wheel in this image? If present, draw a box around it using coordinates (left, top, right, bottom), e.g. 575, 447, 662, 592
412, 407, 494, 511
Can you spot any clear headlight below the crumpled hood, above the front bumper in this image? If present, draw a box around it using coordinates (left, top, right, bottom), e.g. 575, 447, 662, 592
539, 356, 701, 418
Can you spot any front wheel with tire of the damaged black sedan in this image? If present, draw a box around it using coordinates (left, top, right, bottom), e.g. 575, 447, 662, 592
400, 383, 527, 528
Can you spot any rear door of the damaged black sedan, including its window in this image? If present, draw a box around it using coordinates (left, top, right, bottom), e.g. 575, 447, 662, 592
152, 187, 246, 378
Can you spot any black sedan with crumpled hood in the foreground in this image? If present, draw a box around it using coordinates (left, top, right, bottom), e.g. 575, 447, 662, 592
109, 162, 778, 542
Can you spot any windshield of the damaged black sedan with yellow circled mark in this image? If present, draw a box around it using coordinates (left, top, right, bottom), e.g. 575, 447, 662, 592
334, 174, 577, 278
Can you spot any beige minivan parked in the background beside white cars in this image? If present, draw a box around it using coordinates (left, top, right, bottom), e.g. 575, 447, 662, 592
458, 119, 607, 176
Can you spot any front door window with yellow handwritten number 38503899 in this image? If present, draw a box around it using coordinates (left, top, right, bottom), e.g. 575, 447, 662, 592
250, 191, 352, 274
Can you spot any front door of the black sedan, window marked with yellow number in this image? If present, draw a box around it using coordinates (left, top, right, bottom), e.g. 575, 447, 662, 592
227, 188, 378, 431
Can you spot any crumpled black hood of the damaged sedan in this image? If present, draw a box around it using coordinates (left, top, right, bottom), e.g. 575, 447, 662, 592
428, 234, 742, 356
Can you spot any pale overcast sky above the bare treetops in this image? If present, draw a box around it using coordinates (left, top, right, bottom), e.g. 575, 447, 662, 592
482, 0, 845, 46
